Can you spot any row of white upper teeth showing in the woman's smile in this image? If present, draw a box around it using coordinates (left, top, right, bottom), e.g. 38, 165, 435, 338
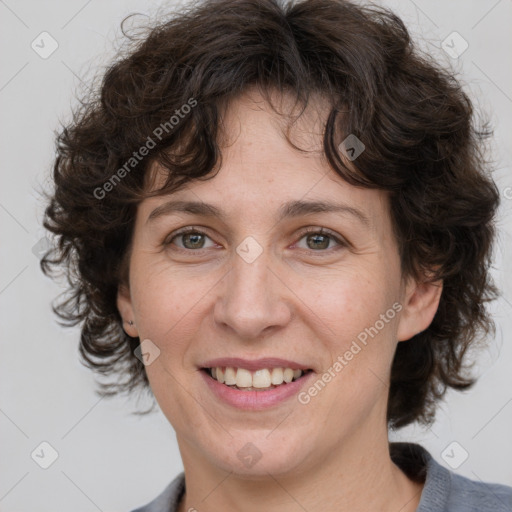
210, 366, 304, 389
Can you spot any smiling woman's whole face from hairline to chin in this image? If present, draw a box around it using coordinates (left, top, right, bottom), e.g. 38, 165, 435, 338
118, 87, 440, 478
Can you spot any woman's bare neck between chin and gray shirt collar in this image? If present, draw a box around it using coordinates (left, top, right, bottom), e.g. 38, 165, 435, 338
178, 424, 423, 512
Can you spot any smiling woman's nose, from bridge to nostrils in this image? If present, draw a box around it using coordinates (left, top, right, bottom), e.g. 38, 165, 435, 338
214, 246, 292, 340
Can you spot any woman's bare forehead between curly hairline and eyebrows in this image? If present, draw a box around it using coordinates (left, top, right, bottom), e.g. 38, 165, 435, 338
142, 90, 388, 228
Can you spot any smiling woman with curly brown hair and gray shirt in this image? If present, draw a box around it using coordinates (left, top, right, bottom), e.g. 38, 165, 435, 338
42, 0, 512, 512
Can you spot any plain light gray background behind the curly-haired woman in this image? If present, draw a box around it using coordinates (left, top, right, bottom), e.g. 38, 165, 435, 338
0, 0, 512, 512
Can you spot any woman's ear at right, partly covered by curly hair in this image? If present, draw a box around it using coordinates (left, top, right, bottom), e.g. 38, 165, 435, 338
397, 278, 443, 341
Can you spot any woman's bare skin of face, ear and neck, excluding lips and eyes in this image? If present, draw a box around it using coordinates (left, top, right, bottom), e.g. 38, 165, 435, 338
118, 90, 442, 512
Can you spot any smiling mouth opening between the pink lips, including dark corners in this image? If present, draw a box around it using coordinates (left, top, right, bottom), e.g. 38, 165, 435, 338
200, 366, 313, 392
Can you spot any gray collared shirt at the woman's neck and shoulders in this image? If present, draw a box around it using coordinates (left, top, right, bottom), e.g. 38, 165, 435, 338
133, 443, 512, 512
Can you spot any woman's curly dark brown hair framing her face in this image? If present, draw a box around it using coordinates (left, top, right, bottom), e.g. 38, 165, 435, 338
41, 0, 499, 428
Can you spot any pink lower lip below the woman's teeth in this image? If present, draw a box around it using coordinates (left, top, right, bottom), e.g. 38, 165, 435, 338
200, 370, 314, 411
